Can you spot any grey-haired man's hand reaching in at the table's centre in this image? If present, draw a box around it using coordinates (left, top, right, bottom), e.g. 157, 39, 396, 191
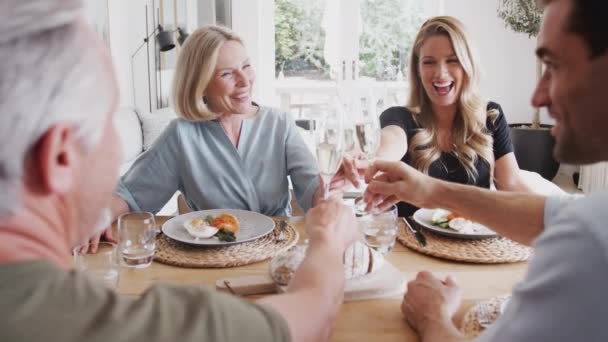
306, 199, 358, 252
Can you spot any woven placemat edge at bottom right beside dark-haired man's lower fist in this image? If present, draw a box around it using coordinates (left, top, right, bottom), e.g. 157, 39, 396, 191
460, 295, 511, 339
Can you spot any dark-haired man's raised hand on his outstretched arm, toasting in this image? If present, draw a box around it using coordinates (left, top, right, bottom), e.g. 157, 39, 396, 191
364, 160, 437, 210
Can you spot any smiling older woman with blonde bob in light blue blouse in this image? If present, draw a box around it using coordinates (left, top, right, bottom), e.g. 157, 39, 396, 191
106, 26, 344, 226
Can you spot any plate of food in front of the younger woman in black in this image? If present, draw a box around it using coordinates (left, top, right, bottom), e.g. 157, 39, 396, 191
414, 209, 497, 239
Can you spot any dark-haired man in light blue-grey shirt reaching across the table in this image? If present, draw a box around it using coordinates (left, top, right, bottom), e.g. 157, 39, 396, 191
366, 0, 608, 342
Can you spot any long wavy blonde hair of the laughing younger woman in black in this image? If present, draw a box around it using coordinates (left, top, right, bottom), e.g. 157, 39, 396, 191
408, 16, 497, 180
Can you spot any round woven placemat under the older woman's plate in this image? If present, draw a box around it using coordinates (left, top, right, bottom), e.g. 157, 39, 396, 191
154, 219, 300, 268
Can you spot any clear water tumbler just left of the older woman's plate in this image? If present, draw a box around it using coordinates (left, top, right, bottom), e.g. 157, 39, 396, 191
118, 212, 156, 268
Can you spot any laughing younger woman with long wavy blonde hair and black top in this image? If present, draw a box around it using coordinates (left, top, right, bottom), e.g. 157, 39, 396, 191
351, 16, 529, 216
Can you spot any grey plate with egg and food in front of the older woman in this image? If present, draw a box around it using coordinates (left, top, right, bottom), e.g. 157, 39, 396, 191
162, 209, 274, 246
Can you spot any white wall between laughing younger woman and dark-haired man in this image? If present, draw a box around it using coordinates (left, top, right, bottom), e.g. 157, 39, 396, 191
444, 0, 552, 123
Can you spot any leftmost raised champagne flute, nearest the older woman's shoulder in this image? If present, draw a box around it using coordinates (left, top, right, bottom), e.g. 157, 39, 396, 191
315, 99, 344, 199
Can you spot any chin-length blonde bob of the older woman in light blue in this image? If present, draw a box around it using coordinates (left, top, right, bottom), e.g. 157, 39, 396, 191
173, 25, 244, 121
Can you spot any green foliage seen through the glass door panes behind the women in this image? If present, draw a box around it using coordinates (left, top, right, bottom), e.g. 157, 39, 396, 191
275, 0, 423, 80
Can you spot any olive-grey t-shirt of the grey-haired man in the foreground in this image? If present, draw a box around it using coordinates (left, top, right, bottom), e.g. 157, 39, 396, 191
0, 261, 290, 342
